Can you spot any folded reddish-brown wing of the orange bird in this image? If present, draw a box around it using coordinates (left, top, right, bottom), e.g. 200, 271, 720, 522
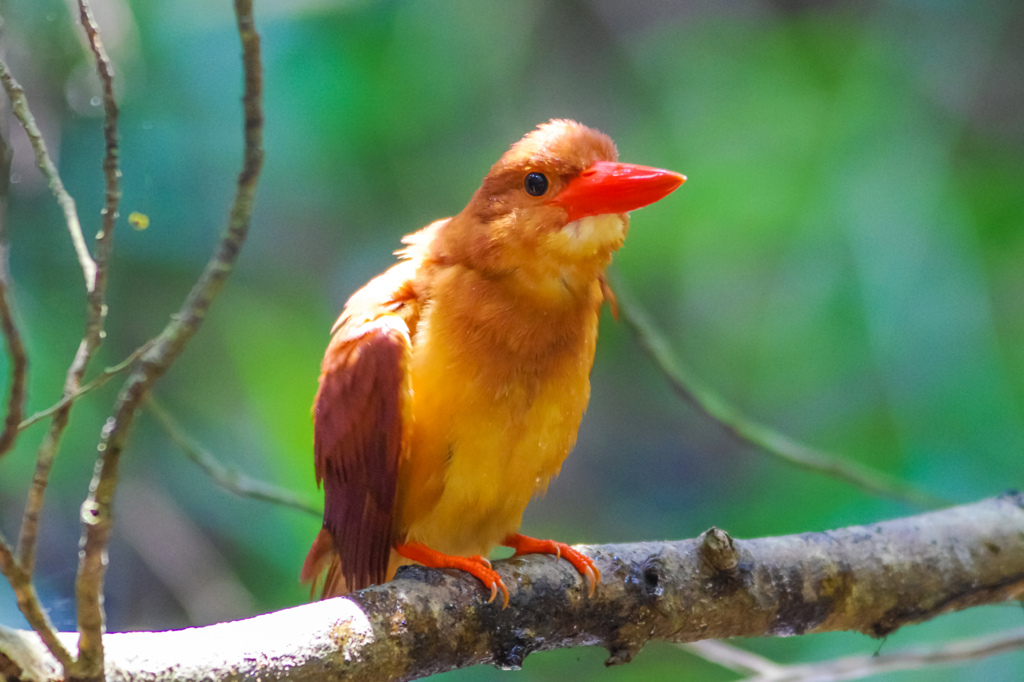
302, 261, 418, 596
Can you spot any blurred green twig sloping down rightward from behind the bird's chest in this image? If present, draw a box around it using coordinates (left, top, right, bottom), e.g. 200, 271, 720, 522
615, 286, 950, 509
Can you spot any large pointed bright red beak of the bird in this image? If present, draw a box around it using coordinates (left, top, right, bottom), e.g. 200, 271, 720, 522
549, 161, 686, 222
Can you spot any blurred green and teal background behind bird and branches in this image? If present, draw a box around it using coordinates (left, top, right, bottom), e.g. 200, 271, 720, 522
0, 0, 1024, 682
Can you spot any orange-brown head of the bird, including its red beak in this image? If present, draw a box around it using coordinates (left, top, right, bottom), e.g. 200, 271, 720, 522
436, 120, 686, 301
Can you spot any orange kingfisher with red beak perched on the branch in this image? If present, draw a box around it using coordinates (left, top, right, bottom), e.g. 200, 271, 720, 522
300, 119, 686, 607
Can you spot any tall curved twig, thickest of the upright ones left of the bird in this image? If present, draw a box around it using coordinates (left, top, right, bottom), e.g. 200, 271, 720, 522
74, 0, 263, 678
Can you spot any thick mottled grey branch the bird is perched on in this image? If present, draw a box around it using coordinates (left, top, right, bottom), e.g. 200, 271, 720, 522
0, 493, 1024, 682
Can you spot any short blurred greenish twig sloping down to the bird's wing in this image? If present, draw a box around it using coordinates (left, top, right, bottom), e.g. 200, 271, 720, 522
146, 395, 324, 518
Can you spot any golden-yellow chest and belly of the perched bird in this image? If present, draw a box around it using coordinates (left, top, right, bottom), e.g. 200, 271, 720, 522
398, 276, 599, 554
